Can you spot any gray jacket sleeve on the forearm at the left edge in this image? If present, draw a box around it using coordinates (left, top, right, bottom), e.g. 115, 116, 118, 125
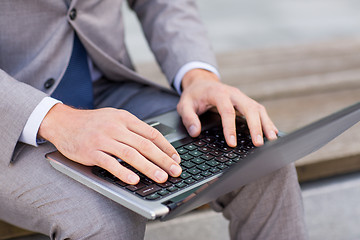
0, 70, 46, 165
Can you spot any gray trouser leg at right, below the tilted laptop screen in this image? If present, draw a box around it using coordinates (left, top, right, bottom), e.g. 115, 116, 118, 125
212, 164, 308, 240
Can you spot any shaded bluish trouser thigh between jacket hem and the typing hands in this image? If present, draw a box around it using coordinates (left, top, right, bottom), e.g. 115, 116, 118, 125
94, 79, 179, 119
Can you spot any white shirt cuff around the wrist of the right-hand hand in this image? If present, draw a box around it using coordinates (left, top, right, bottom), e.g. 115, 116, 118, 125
173, 61, 220, 94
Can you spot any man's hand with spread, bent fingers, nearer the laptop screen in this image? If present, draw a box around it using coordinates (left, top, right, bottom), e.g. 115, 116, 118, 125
177, 69, 278, 147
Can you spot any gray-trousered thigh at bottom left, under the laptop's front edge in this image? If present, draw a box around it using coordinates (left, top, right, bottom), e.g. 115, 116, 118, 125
0, 144, 145, 239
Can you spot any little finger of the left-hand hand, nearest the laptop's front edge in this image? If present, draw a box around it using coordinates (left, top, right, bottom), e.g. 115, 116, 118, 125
96, 151, 140, 184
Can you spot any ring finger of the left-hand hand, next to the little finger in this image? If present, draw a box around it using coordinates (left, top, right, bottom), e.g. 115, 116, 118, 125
102, 141, 173, 183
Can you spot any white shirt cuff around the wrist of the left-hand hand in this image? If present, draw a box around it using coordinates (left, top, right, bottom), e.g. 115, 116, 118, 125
19, 97, 61, 147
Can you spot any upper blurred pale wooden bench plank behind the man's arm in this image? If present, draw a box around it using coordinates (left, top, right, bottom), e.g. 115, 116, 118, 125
137, 38, 360, 96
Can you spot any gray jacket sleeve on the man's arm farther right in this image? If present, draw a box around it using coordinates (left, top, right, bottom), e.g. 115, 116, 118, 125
128, 0, 217, 83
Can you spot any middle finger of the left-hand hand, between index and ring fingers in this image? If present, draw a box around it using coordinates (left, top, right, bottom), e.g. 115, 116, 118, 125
117, 131, 182, 177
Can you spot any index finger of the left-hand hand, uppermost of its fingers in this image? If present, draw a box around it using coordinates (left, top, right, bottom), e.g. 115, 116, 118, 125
126, 112, 181, 163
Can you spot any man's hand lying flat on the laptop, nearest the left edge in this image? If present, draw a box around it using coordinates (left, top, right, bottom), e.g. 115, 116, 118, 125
39, 104, 181, 184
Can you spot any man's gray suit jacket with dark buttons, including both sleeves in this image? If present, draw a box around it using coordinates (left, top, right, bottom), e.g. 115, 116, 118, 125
0, 0, 216, 164
